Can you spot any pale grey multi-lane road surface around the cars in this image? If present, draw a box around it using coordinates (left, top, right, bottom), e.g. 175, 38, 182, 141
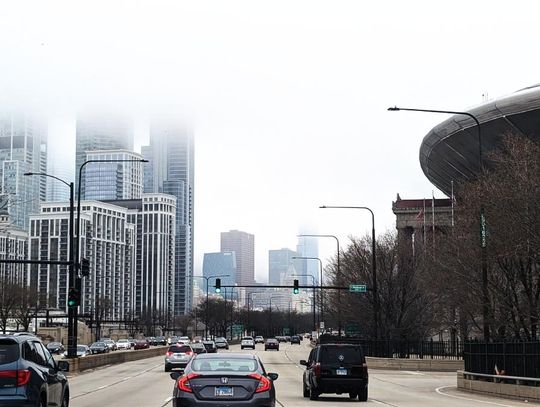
69, 340, 525, 407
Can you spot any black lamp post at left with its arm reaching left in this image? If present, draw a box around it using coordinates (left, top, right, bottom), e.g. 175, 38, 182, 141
23, 172, 75, 358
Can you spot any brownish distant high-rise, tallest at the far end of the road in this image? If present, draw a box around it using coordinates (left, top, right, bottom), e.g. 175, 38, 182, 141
221, 230, 255, 285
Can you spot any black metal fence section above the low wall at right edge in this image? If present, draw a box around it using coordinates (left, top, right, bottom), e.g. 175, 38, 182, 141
463, 342, 540, 378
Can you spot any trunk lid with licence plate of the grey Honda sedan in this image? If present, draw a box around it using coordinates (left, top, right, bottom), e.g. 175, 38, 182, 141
189, 372, 259, 401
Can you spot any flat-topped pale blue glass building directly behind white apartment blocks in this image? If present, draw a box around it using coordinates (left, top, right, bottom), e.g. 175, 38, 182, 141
84, 150, 143, 200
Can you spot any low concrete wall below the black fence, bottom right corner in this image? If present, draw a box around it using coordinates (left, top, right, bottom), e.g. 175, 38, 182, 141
457, 371, 540, 401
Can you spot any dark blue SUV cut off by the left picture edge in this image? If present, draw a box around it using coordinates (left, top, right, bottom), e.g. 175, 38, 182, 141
0, 335, 69, 407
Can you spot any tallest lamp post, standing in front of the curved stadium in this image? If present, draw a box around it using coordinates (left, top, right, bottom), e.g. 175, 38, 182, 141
388, 106, 491, 342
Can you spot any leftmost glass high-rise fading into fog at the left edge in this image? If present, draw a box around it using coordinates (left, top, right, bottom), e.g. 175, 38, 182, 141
0, 114, 47, 230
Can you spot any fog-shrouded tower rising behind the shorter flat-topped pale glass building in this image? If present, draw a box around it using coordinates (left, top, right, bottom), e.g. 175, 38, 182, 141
75, 115, 133, 199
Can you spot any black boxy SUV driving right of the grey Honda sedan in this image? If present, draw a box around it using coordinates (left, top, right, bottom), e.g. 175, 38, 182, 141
300, 339, 368, 401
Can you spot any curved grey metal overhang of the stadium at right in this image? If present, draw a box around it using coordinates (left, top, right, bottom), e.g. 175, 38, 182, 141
420, 85, 540, 196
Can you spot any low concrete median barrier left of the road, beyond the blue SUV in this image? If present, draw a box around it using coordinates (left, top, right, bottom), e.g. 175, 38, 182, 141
66, 346, 167, 373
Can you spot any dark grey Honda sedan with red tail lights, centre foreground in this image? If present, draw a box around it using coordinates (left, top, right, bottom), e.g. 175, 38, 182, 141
171, 353, 278, 407
